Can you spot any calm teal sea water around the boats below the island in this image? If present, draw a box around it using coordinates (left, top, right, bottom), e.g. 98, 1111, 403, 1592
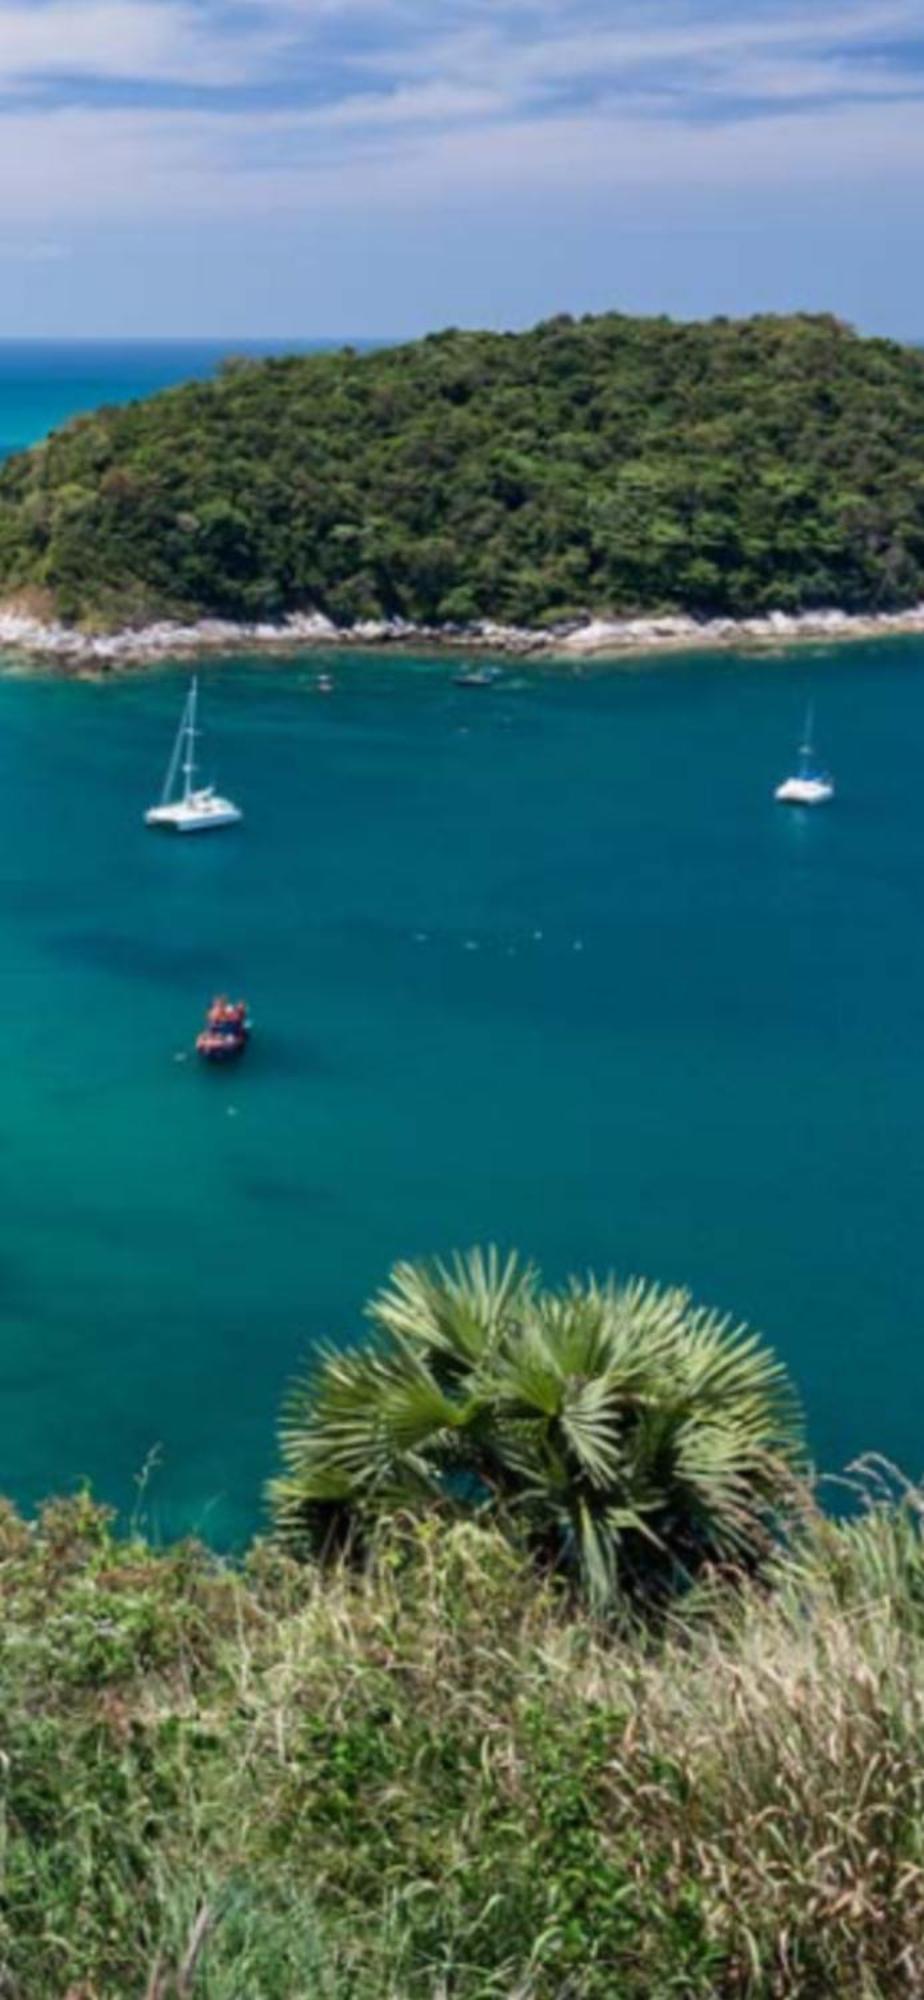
0, 350, 924, 1540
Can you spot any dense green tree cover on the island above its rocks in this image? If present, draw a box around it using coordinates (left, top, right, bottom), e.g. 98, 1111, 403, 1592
0, 314, 924, 624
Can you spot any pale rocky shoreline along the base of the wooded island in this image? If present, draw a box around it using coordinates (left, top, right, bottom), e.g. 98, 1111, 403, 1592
0, 604, 924, 672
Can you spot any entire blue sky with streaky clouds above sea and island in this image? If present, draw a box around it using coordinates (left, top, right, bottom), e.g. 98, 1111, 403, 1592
0, 0, 924, 340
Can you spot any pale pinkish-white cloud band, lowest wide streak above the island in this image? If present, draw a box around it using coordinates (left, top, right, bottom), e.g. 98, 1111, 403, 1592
0, 86, 924, 232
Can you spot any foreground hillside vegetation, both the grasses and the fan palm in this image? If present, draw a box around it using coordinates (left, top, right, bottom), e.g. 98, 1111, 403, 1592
0, 1252, 924, 2000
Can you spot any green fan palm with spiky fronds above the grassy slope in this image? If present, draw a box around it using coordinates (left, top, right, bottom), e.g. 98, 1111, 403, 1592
270, 1250, 800, 1610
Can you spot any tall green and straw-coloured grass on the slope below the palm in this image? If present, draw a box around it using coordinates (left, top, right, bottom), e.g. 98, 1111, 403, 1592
0, 1478, 924, 2000
